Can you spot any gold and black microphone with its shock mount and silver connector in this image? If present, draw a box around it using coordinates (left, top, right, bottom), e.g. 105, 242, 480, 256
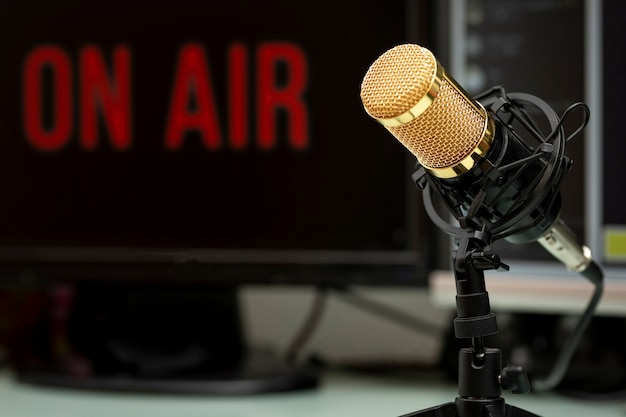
361, 44, 599, 275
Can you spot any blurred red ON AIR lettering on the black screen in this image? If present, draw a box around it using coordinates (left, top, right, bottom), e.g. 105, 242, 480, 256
22, 42, 310, 152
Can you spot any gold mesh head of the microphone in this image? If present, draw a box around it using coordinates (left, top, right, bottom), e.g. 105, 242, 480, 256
361, 44, 494, 178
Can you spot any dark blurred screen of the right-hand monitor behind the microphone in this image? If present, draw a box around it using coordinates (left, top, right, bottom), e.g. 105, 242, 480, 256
458, 0, 584, 260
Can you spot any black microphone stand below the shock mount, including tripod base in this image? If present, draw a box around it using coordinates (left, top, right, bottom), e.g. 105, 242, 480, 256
401, 218, 538, 417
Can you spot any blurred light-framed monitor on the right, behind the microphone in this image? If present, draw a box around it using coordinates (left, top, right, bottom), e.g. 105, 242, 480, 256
431, 0, 626, 317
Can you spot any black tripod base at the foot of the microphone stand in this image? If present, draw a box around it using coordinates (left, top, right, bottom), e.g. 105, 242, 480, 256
401, 398, 539, 417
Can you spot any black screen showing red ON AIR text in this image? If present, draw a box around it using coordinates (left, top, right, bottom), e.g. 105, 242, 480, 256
0, 0, 424, 282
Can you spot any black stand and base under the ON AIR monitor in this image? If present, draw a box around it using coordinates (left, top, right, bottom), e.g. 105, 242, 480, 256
17, 283, 318, 395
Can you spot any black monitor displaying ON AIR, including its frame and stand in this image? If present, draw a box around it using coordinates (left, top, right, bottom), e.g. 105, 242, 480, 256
0, 0, 429, 391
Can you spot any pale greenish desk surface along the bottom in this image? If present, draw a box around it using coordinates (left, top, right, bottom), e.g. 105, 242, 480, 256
0, 371, 626, 417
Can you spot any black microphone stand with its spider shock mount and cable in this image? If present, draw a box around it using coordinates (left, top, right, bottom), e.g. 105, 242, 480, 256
392, 87, 603, 417
